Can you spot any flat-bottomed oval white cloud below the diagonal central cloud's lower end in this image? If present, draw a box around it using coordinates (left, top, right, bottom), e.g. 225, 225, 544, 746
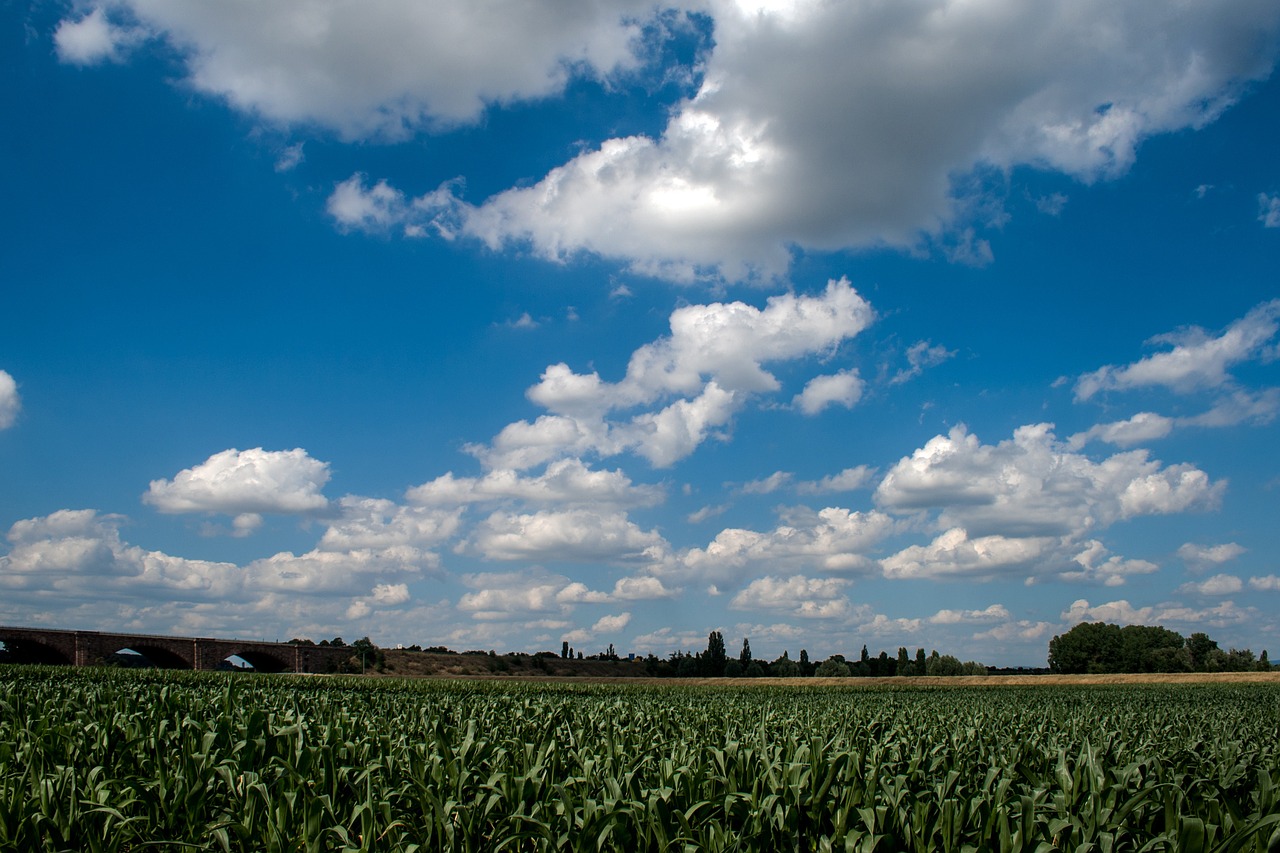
465, 510, 667, 562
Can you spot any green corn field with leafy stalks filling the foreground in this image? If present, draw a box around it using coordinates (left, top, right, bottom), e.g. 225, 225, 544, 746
0, 667, 1280, 852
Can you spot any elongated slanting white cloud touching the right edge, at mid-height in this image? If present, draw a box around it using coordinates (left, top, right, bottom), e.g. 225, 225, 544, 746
1075, 300, 1280, 400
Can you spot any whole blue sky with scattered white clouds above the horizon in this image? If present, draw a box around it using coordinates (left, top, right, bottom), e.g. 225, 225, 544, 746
0, 0, 1280, 665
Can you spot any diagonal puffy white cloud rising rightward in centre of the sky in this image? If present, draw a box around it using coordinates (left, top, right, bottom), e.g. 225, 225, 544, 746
468, 279, 873, 470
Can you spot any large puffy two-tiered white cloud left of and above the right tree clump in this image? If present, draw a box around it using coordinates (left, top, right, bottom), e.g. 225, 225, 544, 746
876, 424, 1225, 585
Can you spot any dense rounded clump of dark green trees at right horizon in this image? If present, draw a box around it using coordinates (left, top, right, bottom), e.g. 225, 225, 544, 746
1048, 622, 1271, 674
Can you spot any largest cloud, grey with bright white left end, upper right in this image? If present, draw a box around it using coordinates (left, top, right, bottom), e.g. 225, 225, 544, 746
381, 0, 1280, 280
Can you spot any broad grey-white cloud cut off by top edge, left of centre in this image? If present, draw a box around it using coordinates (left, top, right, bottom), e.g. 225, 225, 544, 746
70, 0, 653, 138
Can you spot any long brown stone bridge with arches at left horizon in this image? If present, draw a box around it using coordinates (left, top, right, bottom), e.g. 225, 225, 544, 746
0, 626, 352, 672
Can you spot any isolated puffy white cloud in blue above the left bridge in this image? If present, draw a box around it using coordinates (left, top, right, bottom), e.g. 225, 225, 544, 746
142, 447, 329, 515
